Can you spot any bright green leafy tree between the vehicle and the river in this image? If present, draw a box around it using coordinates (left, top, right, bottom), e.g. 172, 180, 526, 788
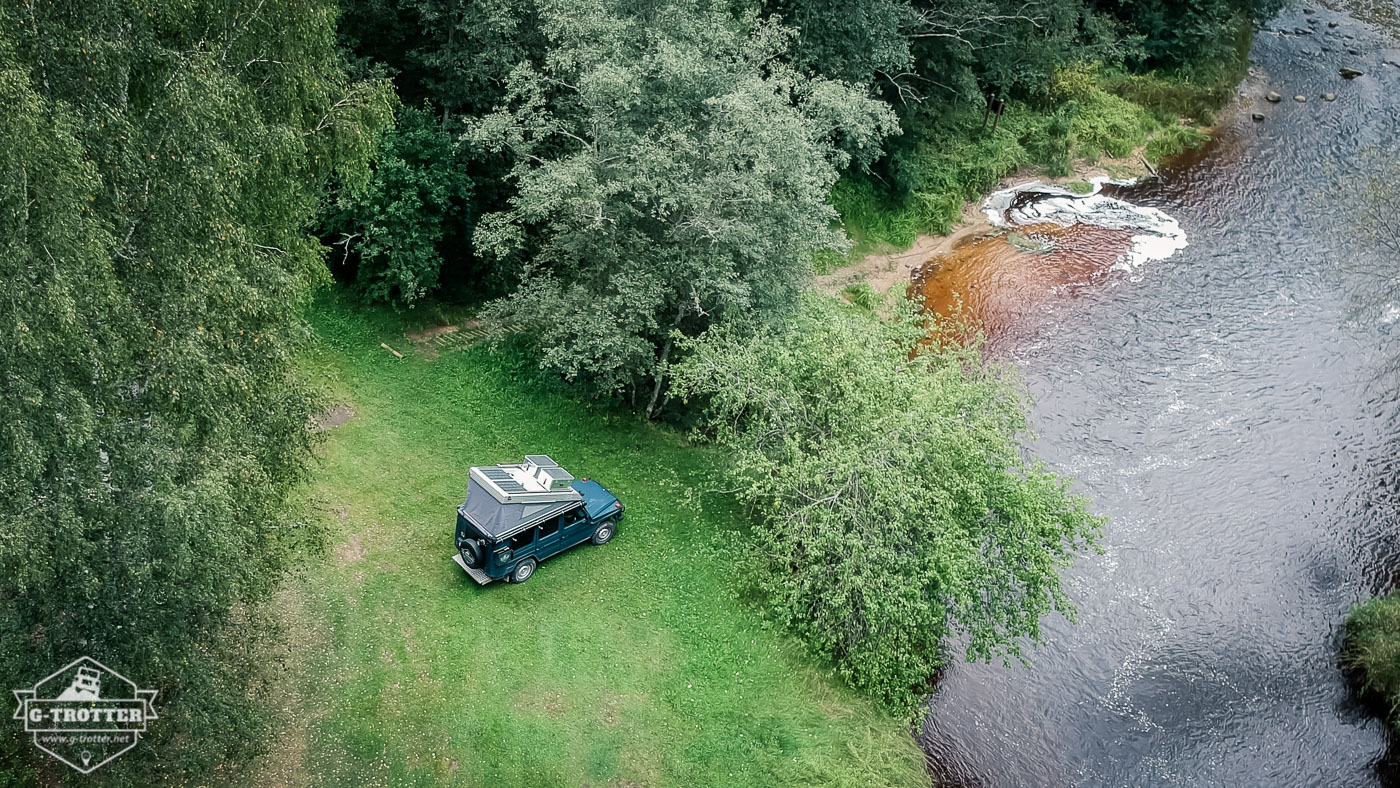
673, 294, 1102, 710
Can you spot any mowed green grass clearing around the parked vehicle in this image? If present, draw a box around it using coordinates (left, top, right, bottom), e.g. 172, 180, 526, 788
256, 295, 928, 787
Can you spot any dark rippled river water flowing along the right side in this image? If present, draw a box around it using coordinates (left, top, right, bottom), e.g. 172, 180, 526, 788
921, 7, 1400, 785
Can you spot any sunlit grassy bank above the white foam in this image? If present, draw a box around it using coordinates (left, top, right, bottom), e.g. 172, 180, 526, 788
819, 61, 1249, 263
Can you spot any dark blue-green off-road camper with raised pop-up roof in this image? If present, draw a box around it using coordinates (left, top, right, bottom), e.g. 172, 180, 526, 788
452, 455, 624, 585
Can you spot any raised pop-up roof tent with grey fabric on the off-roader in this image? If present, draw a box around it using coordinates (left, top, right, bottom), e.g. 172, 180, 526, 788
456, 455, 584, 540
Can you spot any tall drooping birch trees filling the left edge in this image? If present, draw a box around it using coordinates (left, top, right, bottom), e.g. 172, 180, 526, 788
0, 0, 389, 784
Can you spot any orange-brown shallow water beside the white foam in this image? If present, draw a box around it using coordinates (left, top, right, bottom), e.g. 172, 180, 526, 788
910, 223, 1134, 350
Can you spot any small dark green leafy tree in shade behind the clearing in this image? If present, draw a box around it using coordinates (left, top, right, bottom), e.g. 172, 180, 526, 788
322, 106, 472, 305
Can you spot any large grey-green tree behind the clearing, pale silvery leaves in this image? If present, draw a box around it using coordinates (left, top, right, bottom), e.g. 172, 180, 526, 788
468, 0, 893, 414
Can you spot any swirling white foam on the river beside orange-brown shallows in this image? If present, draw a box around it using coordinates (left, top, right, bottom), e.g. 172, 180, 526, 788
981, 178, 1187, 270
